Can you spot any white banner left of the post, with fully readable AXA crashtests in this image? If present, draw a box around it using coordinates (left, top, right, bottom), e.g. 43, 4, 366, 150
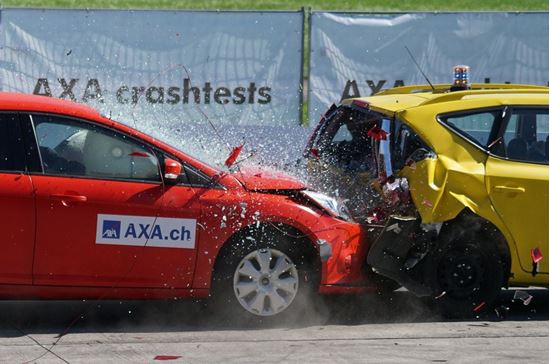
0, 9, 303, 166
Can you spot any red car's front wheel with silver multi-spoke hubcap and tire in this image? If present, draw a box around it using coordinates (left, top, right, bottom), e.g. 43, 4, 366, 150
211, 235, 318, 321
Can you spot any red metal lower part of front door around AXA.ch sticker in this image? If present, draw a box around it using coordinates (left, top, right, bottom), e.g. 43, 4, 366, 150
32, 176, 200, 288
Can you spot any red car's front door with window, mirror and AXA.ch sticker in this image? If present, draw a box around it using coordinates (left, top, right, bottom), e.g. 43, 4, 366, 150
26, 114, 200, 288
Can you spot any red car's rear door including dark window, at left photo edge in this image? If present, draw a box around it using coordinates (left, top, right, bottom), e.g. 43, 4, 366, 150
0, 113, 35, 284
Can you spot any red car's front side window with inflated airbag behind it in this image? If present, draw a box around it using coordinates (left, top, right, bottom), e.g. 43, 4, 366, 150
32, 115, 161, 182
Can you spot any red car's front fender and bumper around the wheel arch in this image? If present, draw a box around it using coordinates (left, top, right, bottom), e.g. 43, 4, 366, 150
193, 193, 367, 288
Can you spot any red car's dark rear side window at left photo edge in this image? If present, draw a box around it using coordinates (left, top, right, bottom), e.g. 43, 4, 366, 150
0, 113, 25, 172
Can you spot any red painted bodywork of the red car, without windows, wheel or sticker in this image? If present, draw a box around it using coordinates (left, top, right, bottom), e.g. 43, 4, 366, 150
0, 93, 374, 299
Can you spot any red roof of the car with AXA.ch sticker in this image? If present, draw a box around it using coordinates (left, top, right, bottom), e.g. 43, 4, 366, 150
0, 92, 101, 120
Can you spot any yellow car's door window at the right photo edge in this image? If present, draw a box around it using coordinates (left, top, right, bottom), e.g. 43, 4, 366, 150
495, 108, 548, 164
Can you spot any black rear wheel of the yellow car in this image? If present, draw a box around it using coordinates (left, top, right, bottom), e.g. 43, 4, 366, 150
429, 219, 504, 318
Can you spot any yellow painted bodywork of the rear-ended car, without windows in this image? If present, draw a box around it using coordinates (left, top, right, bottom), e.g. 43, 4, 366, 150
352, 85, 549, 285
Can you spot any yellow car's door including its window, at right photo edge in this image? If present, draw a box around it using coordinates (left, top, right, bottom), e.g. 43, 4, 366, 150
486, 107, 548, 273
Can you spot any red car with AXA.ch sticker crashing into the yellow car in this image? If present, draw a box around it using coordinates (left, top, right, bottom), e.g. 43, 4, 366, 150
0, 93, 374, 316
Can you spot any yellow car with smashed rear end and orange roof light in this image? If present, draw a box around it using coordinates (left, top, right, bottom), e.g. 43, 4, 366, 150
304, 84, 548, 317
